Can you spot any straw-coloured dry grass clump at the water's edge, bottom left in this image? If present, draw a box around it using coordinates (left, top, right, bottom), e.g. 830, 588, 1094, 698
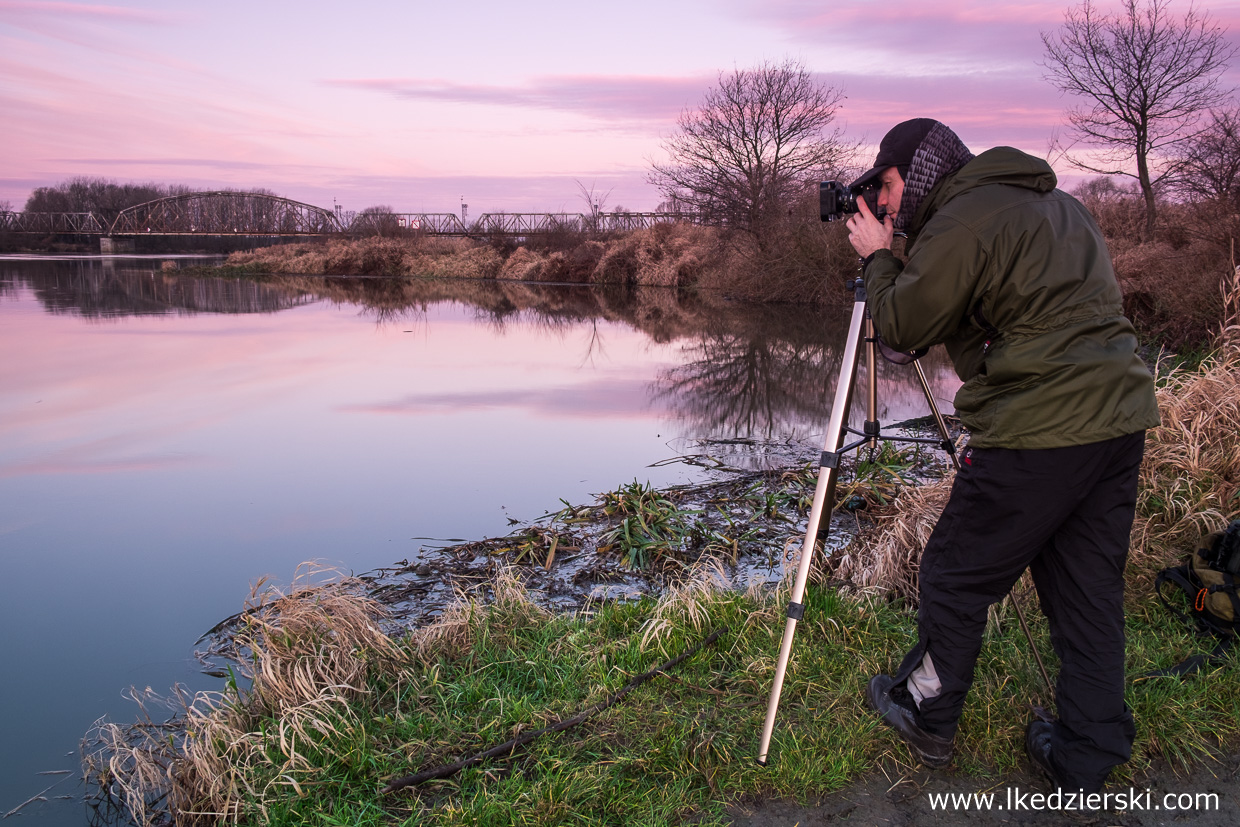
83, 569, 549, 825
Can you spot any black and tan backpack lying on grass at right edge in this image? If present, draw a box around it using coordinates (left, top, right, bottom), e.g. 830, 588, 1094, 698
1147, 520, 1240, 677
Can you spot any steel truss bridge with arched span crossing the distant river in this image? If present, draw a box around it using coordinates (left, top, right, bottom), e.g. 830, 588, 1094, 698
0, 192, 698, 238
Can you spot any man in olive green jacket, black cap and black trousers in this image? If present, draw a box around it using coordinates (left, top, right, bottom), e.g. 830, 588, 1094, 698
848, 118, 1158, 792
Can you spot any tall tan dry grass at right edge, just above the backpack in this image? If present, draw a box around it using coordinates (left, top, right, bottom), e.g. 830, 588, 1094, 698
1132, 345, 1240, 573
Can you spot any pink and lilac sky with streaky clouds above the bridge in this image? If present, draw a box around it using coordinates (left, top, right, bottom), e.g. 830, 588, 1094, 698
0, 0, 1240, 216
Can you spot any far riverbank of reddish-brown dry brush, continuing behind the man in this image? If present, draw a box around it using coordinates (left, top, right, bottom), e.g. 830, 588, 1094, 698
201, 203, 1235, 351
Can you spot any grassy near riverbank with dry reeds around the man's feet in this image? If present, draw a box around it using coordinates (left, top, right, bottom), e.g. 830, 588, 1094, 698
84, 350, 1240, 825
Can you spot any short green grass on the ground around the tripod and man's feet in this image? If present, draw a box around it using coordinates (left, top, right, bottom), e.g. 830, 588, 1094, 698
213, 589, 1240, 826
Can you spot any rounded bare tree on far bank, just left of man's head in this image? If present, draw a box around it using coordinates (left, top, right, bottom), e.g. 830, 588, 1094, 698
647, 60, 854, 247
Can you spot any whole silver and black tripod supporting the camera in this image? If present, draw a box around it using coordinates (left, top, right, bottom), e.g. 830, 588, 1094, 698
758, 278, 1054, 766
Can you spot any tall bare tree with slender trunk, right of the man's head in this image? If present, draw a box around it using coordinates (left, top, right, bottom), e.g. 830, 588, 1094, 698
1042, 0, 1234, 236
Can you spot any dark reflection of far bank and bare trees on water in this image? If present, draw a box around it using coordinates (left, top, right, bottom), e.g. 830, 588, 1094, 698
0, 257, 959, 439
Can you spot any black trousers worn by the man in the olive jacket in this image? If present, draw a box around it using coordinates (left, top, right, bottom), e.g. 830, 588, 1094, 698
895, 431, 1145, 787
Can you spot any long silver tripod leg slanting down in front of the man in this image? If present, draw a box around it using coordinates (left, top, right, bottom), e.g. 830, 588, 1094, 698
758, 296, 866, 766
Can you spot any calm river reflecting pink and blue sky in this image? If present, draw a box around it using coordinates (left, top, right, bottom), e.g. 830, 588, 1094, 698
0, 257, 957, 826
